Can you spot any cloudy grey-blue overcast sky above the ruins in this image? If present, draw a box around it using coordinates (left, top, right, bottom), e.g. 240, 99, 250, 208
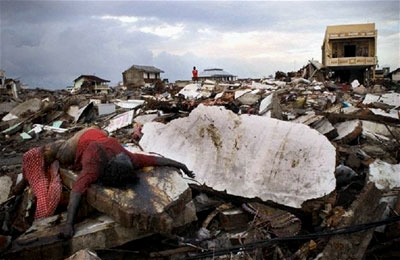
0, 0, 400, 89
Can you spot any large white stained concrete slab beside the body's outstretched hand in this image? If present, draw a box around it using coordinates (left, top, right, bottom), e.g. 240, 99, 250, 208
140, 105, 336, 207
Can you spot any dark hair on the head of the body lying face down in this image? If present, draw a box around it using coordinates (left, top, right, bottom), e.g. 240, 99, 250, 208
98, 153, 138, 187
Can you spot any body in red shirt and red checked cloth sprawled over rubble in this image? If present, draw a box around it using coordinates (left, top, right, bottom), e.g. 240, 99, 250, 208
19, 128, 194, 238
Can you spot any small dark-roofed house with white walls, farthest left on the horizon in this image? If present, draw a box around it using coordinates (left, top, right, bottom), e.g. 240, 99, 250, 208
72, 75, 110, 94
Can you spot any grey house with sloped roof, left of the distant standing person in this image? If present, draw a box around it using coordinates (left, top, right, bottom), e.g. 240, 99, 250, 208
122, 65, 164, 89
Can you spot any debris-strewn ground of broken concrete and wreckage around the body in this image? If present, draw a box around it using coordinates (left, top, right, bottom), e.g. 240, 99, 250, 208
0, 78, 400, 259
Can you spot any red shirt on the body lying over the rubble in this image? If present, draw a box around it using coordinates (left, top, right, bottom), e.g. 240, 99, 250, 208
72, 129, 156, 193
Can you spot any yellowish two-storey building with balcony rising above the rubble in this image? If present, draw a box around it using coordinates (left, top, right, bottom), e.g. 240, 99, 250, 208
322, 23, 378, 82
